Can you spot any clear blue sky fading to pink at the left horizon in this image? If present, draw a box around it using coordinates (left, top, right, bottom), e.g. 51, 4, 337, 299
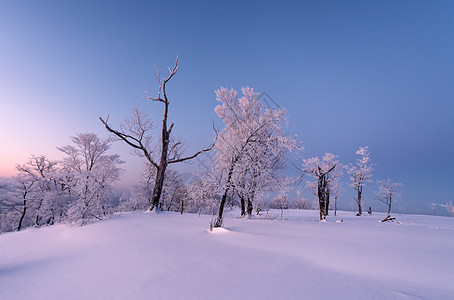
0, 0, 454, 213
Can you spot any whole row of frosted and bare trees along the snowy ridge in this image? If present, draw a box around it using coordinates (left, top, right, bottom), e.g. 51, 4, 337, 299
0, 58, 401, 231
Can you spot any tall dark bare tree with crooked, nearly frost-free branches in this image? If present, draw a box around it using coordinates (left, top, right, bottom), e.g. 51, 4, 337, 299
100, 57, 216, 212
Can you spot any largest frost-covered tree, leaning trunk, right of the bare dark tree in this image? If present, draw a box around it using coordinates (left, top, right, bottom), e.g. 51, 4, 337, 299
214, 87, 297, 227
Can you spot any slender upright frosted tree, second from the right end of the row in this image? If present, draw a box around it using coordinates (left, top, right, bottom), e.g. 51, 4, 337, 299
347, 146, 373, 216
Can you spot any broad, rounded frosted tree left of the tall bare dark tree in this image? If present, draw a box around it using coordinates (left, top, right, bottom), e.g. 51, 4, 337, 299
58, 133, 123, 224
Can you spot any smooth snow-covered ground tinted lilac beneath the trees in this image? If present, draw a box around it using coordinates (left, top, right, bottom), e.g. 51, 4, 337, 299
0, 210, 454, 300
